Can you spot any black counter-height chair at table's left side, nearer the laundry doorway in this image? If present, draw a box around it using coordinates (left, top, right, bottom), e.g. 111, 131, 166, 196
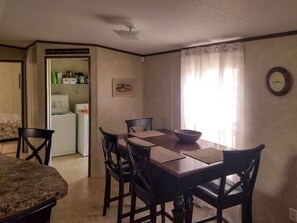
99, 127, 131, 223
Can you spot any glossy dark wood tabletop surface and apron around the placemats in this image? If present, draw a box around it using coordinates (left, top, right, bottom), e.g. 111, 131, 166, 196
127, 129, 226, 191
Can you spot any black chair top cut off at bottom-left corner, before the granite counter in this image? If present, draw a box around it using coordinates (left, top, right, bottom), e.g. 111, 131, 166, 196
0, 198, 56, 223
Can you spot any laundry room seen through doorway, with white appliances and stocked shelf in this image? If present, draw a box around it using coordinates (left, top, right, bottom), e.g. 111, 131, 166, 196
47, 57, 89, 157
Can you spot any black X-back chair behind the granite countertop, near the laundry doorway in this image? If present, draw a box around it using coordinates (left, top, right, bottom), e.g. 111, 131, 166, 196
16, 128, 55, 165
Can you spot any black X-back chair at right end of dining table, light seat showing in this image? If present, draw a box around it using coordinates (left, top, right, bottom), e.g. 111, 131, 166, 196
193, 144, 265, 223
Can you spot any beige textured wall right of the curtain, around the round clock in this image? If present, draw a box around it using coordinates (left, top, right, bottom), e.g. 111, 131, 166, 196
245, 36, 297, 223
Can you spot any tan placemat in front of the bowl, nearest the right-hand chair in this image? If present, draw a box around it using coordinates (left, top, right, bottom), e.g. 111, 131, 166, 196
184, 148, 223, 164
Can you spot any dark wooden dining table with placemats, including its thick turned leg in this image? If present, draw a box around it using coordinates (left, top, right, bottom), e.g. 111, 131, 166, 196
119, 129, 227, 223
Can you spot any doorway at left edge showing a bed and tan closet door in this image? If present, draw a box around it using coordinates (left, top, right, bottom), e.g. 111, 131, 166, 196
0, 61, 24, 154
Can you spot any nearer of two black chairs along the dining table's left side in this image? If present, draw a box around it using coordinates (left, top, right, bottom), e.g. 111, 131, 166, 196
126, 138, 176, 223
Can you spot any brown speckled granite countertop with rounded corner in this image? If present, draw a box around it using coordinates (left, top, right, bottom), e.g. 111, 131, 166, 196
0, 154, 68, 218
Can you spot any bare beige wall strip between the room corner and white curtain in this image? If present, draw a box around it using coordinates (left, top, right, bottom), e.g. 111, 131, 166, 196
143, 52, 180, 129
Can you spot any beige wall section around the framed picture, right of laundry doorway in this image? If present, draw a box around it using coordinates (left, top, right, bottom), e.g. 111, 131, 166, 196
94, 48, 143, 176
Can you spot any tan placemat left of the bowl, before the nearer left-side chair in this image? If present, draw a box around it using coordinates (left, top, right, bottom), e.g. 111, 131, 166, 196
151, 146, 185, 163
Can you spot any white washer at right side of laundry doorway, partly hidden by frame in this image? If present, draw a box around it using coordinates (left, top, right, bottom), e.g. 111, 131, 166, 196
75, 104, 89, 156
